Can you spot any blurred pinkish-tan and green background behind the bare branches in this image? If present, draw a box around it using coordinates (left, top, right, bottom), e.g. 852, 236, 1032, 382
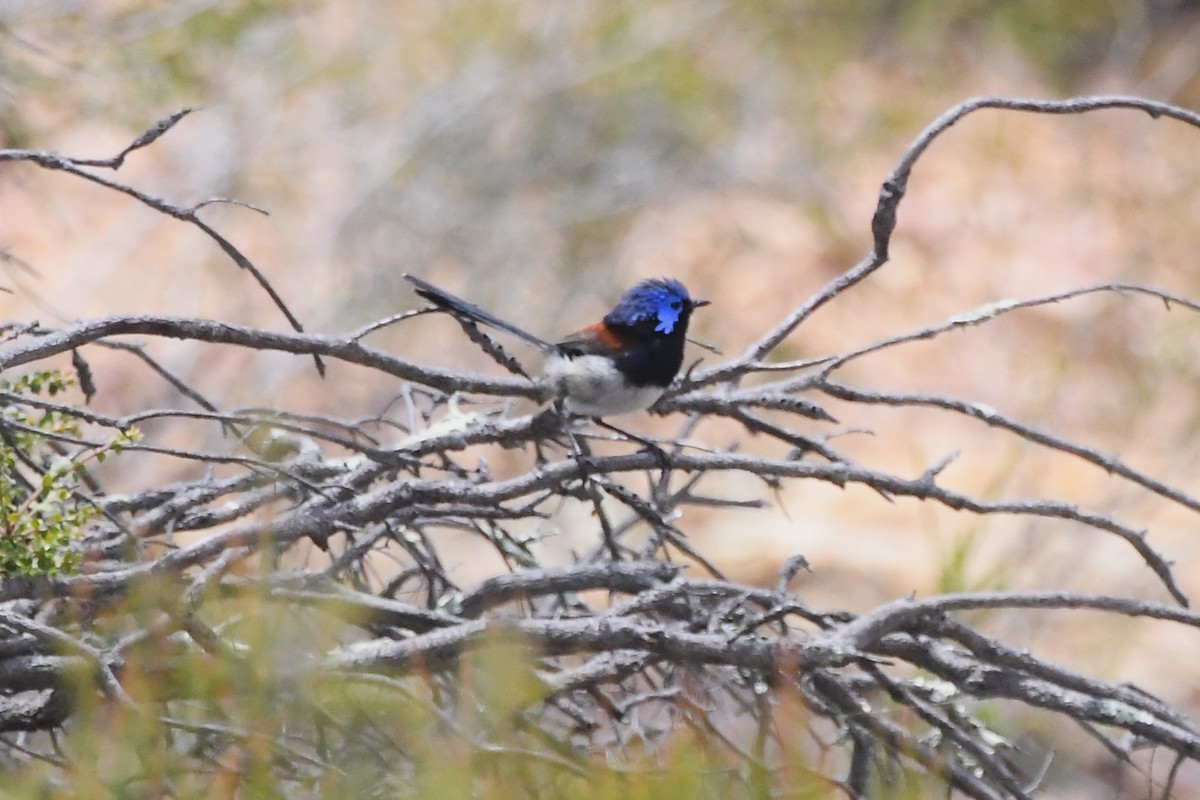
0, 0, 1200, 798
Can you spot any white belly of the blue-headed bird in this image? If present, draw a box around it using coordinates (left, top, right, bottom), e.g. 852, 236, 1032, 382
545, 353, 665, 416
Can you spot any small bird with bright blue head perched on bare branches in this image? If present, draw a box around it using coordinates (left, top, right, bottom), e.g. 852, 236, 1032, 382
404, 275, 708, 417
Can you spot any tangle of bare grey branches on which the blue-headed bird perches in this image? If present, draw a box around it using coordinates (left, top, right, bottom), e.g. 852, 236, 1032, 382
0, 97, 1200, 798
